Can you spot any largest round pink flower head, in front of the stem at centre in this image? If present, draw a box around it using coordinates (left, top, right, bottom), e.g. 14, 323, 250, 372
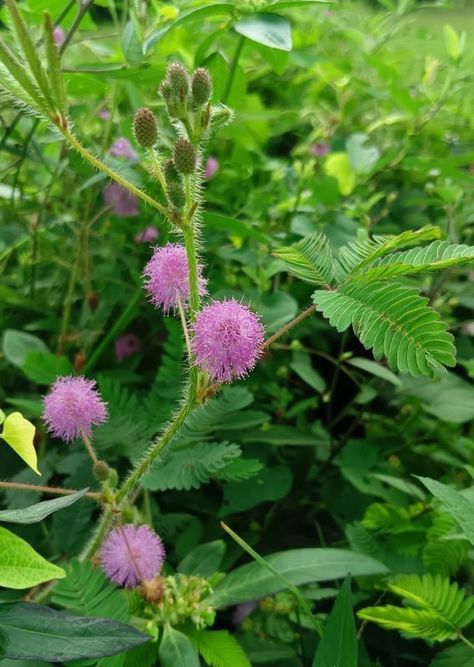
193, 299, 265, 382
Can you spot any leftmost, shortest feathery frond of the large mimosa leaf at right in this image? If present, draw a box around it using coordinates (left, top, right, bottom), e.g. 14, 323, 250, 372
273, 233, 334, 286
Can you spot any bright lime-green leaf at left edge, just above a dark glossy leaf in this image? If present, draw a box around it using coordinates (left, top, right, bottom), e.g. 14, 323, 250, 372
0, 527, 66, 588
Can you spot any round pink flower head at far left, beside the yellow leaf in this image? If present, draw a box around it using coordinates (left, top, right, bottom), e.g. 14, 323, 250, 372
43, 376, 107, 442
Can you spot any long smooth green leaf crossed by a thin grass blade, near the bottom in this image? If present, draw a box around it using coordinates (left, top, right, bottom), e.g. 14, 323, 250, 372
207, 549, 388, 607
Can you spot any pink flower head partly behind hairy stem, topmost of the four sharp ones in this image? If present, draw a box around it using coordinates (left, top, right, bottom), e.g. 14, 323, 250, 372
143, 243, 207, 313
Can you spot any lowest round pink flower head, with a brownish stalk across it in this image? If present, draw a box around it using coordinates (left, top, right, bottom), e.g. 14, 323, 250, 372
100, 524, 165, 588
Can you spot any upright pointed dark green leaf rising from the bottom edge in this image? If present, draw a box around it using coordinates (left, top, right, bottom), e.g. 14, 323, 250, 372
313, 576, 358, 667
